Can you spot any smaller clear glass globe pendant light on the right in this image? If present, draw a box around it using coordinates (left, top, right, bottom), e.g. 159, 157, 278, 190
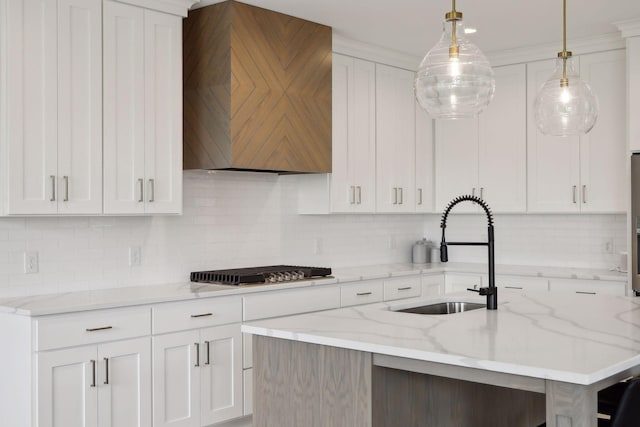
533, 0, 598, 136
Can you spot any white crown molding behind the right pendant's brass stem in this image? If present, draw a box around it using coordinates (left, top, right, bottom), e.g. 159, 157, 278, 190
486, 32, 624, 67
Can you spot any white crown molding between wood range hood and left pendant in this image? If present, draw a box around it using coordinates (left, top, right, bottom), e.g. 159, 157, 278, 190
333, 31, 421, 71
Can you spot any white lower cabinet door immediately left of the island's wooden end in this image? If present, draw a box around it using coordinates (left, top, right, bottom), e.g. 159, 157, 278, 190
200, 324, 242, 425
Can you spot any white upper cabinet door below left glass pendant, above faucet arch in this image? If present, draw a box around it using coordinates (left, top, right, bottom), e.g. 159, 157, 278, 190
435, 118, 479, 212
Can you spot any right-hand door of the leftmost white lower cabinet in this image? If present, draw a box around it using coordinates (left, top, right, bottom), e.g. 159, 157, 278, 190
97, 337, 151, 427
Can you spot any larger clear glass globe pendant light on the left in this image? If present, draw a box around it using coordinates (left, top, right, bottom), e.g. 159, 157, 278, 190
414, 0, 495, 119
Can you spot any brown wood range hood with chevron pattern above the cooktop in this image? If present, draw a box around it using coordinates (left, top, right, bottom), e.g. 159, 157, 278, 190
183, 1, 332, 173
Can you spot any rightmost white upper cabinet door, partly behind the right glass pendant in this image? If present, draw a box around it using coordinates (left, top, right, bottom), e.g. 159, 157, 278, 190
580, 50, 628, 212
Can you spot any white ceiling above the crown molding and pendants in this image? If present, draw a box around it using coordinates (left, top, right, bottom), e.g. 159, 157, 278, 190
198, 0, 640, 58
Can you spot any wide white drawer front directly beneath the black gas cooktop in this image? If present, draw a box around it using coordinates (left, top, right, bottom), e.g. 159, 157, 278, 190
242, 286, 340, 321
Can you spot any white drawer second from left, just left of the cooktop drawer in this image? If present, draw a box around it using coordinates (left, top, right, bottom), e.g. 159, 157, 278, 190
153, 297, 242, 334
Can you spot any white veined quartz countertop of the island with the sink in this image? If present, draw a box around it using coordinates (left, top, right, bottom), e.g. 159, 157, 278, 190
242, 289, 640, 385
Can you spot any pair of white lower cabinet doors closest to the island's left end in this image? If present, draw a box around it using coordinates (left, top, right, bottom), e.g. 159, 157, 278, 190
153, 324, 243, 427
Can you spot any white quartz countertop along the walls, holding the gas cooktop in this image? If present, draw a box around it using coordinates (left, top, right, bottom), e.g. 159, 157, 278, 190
0, 263, 627, 316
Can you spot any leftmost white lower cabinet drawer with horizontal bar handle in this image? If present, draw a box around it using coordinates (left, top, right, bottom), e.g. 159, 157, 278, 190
33, 307, 151, 351
